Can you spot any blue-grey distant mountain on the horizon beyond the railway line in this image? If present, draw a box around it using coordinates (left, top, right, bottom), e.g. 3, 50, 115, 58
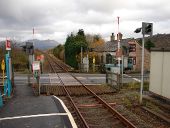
25, 39, 59, 50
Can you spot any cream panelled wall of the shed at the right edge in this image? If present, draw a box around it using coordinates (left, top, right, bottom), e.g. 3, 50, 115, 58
149, 51, 170, 98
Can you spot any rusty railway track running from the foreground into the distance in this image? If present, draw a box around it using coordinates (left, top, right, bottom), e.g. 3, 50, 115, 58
44, 54, 136, 128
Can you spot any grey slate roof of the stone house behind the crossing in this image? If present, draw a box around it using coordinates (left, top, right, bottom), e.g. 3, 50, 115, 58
94, 38, 132, 52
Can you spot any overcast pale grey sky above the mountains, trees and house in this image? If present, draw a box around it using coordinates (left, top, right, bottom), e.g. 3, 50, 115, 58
0, 0, 170, 43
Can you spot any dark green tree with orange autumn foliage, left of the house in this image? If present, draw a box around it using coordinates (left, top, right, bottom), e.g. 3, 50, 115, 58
53, 29, 104, 69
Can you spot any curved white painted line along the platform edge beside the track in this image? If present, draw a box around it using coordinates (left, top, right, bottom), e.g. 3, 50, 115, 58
53, 95, 77, 128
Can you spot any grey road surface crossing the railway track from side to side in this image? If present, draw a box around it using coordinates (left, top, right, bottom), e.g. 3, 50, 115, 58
13, 73, 149, 85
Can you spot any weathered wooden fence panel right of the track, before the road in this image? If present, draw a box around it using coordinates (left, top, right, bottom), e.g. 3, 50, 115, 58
106, 71, 121, 90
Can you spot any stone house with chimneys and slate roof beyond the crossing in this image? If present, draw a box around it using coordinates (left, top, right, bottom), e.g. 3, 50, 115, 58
94, 33, 150, 72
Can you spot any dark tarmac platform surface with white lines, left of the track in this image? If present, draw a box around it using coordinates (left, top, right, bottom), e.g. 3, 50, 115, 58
0, 76, 77, 128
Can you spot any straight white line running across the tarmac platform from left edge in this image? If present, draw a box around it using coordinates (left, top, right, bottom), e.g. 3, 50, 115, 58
0, 113, 67, 121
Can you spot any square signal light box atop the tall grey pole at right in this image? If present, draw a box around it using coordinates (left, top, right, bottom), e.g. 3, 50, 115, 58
142, 22, 153, 36
